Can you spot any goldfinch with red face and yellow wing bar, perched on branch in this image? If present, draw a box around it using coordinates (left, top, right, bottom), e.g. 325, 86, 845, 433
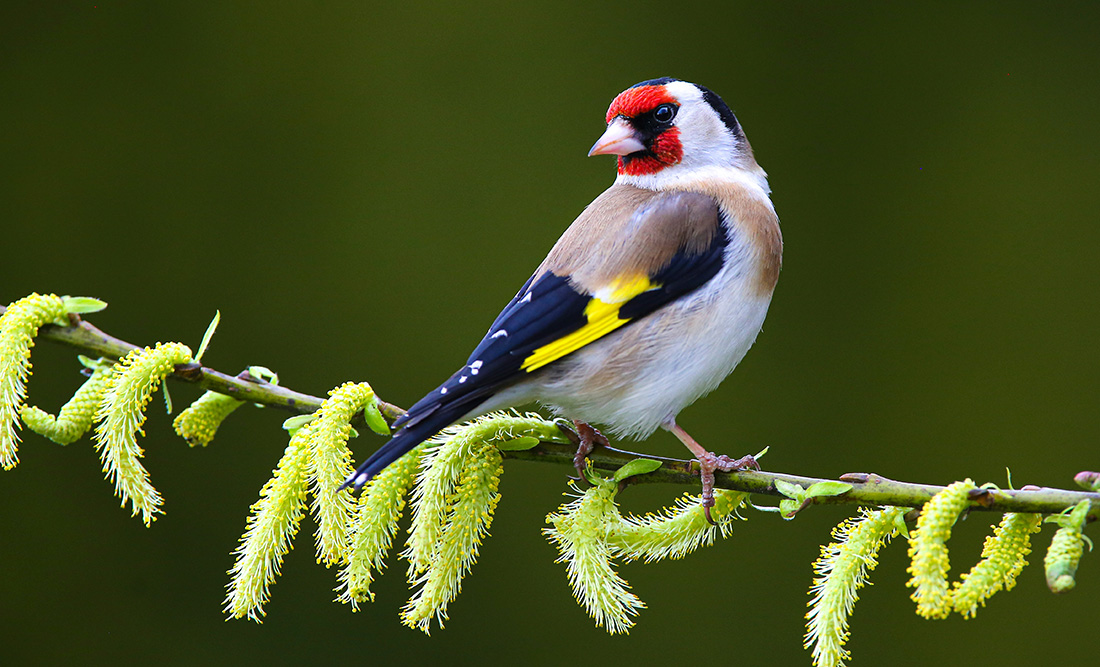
344, 78, 783, 517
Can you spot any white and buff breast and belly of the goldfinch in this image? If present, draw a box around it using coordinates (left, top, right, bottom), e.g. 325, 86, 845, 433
514, 224, 771, 437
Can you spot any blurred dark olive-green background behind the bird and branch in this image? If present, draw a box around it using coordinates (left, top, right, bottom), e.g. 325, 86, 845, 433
0, 0, 1100, 665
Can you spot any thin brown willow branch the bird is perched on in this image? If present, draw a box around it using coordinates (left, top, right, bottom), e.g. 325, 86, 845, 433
12, 306, 1100, 521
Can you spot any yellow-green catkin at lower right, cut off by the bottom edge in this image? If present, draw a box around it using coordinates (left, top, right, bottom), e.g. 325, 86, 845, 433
804, 507, 909, 667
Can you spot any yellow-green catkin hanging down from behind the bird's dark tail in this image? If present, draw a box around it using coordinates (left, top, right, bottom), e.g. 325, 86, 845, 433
338, 445, 425, 611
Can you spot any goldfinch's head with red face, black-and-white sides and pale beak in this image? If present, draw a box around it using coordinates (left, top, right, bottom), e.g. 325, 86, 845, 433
589, 77, 762, 185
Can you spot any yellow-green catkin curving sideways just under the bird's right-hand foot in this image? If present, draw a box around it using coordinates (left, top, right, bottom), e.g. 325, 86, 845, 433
608, 489, 748, 562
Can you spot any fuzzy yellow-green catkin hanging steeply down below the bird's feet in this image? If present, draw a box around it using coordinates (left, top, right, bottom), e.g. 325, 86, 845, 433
543, 481, 646, 635
